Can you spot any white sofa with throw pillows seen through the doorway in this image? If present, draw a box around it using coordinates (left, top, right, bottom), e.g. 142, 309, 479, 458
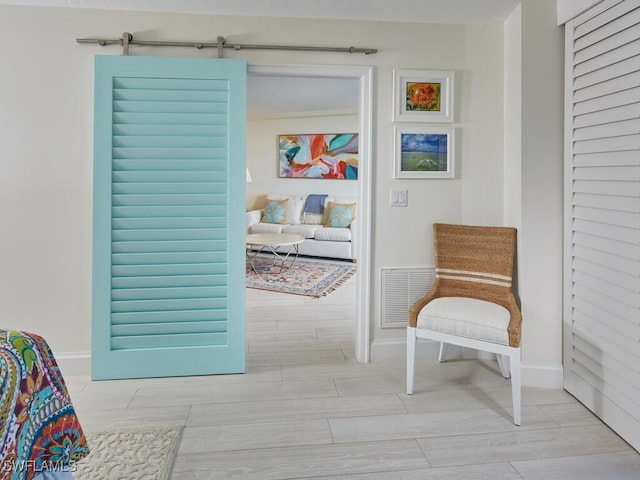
246, 195, 357, 261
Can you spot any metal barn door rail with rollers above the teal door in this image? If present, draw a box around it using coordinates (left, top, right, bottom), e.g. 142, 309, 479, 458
76, 32, 378, 58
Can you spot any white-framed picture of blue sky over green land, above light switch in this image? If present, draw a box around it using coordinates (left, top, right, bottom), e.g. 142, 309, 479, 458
394, 126, 455, 178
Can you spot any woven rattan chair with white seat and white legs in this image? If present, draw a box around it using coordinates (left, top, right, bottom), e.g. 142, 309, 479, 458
407, 224, 522, 425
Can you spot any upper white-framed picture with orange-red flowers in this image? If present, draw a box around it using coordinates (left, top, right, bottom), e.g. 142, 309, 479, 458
393, 69, 453, 122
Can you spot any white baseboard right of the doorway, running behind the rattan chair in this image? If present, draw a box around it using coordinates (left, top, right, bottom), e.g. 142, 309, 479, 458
371, 338, 564, 388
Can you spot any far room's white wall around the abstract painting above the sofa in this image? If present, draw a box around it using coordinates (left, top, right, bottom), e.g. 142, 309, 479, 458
247, 114, 360, 209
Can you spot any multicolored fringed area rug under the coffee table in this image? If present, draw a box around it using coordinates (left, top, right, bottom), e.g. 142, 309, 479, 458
247, 257, 356, 298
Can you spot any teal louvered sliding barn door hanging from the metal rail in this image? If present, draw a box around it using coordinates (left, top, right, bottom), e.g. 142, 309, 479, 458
91, 56, 246, 379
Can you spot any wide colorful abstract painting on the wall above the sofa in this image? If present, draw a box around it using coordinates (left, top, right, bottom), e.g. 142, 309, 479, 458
278, 133, 358, 180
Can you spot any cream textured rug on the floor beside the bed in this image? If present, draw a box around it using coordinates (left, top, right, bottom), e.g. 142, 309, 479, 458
73, 426, 182, 480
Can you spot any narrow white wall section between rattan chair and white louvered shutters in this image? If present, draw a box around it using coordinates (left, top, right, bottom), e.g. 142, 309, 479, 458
505, 0, 564, 388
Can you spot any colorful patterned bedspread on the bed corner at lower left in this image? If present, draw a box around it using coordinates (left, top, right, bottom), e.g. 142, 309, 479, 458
0, 329, 89, 480
